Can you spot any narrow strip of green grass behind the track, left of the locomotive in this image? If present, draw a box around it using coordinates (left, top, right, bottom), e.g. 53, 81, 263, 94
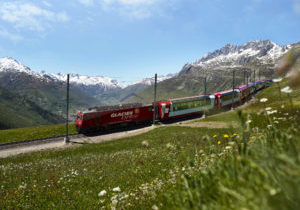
0, 123, 77, 144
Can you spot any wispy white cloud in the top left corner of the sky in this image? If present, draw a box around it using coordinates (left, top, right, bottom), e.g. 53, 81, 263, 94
0, 2, 69, 31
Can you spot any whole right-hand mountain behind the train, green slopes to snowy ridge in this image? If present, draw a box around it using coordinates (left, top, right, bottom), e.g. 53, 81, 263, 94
127, 40, 293, 103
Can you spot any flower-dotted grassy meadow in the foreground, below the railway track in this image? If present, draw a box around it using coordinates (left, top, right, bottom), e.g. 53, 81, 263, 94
0, 80, 300, 209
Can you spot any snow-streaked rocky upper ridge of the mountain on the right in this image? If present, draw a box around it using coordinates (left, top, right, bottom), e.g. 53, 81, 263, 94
182, 40, 292, 74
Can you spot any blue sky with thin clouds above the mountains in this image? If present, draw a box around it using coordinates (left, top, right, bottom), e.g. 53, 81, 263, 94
0, 0, 300, 82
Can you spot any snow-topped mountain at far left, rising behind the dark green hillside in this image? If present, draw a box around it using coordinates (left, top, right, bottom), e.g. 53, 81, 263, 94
0, 58, 98, 116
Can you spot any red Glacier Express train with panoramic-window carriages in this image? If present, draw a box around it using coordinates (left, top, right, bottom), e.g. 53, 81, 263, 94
75, 79, 272, 133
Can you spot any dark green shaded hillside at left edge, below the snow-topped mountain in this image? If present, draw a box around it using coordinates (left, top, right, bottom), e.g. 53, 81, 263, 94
0, 87, 64, 130
